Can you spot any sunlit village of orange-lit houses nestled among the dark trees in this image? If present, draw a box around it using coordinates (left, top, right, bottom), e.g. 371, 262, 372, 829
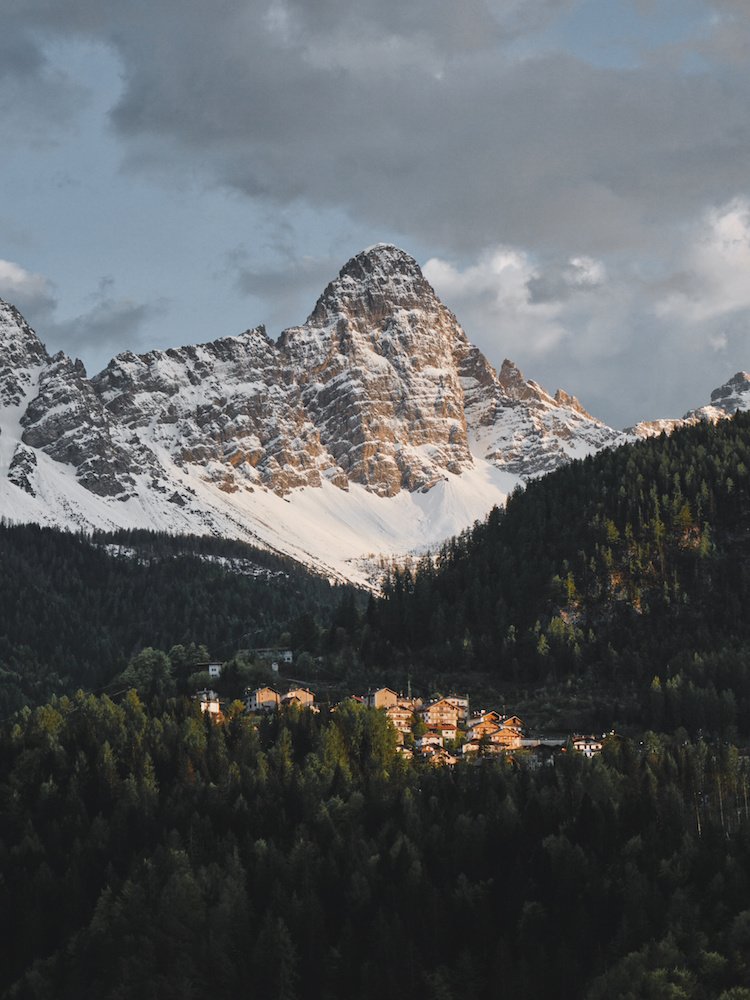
195, 651, 605, 766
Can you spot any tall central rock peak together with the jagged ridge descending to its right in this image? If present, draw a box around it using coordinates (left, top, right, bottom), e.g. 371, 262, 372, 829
279, 245, 620, 488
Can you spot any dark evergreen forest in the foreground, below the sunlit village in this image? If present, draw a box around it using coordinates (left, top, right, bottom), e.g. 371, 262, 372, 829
0, 692, 750, 1000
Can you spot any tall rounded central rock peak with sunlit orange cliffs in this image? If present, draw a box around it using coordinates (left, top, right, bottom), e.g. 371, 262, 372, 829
279, 246, 472, 496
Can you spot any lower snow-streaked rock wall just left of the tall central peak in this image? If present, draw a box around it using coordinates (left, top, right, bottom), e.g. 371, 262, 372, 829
92, 328, 329, 492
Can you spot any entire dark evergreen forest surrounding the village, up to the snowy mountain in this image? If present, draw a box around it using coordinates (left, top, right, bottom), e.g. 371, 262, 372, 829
0, 414, 750, 1000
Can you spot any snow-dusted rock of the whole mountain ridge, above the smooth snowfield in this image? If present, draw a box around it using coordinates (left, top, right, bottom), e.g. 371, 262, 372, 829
0, 245, 617, 506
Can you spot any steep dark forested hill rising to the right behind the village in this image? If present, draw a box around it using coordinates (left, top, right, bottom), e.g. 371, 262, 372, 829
364, 414, 750, 735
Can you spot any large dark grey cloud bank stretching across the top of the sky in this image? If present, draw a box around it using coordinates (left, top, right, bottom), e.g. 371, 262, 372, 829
10, 0, 750, 262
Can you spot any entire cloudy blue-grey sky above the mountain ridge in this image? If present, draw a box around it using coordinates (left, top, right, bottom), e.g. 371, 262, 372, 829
0, 0, 750, 426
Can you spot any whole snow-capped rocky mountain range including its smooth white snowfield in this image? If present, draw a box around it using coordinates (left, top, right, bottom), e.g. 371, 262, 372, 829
0, 244, 747, 580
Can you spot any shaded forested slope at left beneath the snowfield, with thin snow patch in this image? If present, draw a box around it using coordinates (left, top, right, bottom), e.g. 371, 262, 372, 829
0, 523, 356, 718
